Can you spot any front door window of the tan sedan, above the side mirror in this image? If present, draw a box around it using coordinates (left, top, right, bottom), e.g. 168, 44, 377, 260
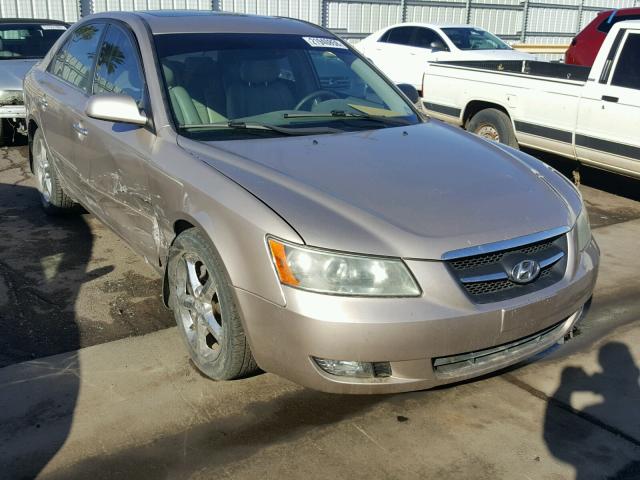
93, 25, 144, 106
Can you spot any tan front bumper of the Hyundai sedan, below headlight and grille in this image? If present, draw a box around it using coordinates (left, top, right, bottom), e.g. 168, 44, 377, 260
236, 241, 599, 394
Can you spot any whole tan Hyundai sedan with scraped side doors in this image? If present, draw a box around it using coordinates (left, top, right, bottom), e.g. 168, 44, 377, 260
25, 12, 599, 393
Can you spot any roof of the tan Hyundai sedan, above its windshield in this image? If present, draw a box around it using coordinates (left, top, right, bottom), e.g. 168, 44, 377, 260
93, 10, 328, 37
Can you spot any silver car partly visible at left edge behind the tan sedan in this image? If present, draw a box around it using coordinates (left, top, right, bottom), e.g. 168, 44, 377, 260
0, 18, 69, 146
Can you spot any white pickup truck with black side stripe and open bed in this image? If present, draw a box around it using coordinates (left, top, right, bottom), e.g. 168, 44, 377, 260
423, 20, 640, 177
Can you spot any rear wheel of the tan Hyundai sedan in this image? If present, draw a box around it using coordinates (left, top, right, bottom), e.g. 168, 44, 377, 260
29, 129, 77, 215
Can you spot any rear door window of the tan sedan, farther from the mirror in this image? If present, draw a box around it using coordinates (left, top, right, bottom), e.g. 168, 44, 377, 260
49, 24, 104, 93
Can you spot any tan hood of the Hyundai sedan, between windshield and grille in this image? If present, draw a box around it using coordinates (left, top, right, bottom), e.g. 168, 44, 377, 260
179, 120, 575, 259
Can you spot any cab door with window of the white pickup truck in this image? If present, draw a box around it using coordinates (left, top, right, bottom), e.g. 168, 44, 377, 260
575, 30, 640, 175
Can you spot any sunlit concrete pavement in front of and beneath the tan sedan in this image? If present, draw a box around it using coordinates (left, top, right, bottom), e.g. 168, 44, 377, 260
0, 220, 640, 480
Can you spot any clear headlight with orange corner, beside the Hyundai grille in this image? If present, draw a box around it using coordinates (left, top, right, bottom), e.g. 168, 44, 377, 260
268, 238, 421, 297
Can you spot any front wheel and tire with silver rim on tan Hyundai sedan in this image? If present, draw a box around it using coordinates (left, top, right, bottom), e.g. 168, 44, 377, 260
167, 228, 258, 380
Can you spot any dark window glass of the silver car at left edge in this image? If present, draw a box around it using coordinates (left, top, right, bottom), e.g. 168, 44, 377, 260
0, 23, 67, 60
